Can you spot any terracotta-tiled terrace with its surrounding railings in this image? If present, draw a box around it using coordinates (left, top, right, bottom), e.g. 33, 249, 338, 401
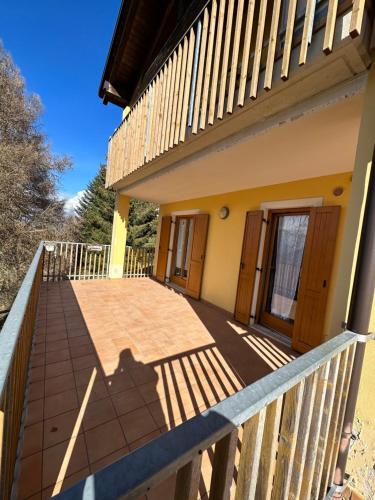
0, 243, 374, 499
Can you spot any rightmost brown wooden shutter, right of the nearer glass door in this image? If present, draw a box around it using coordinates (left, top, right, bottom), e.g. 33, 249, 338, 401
292, 207, 340, 352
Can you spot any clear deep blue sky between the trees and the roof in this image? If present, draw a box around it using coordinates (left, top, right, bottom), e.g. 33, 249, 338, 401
0, 0, 121, 208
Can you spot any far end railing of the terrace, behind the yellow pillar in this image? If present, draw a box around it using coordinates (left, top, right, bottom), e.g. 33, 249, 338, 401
43, 241, 155, 281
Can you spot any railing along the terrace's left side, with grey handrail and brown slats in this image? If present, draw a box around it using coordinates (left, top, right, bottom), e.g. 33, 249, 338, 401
0, 243, 44, 498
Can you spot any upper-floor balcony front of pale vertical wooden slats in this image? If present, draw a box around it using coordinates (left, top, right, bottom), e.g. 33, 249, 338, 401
106, 0, 374, 188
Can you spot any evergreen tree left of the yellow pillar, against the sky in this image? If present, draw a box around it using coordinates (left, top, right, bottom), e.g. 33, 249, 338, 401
76, 165, 115, 245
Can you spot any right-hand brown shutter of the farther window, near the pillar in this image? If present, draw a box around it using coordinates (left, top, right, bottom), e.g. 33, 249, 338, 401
186, 214, 209, 299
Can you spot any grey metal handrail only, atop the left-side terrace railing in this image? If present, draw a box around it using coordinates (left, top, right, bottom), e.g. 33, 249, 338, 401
0, 241, 44, 402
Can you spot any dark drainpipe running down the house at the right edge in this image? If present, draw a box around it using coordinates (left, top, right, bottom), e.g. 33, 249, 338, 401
333, 150, 375, 498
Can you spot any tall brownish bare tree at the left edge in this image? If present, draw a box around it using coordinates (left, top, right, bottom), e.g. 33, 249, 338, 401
0, 44, 71, 310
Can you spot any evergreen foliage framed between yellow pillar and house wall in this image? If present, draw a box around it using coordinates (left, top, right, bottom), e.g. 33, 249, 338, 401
127, 199, 159, 248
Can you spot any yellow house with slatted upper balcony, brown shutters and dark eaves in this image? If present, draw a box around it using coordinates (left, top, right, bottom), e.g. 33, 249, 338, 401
99, 0, 375, 492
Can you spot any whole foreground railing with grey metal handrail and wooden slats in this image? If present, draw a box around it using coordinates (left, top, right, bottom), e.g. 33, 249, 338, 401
55, 331, 374, 500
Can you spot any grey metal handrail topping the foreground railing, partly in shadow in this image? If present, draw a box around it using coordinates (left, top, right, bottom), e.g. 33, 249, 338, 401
58, 331, 359, 500
